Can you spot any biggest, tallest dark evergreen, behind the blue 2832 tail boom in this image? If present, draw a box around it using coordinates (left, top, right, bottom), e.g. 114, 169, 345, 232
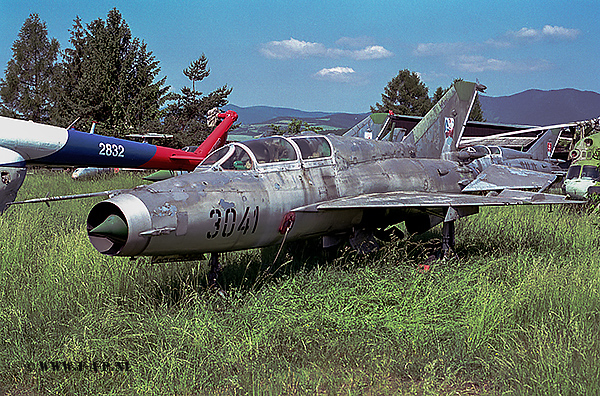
56, 8, 169, 135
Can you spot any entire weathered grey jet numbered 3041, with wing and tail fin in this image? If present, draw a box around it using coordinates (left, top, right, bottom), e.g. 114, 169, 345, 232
87, 82, 576, 258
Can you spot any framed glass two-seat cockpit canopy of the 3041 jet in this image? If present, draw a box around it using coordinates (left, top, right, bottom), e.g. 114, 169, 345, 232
195, 136, 333, 172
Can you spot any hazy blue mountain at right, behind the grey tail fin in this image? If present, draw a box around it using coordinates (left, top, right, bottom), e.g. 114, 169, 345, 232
479, 88, 600, 125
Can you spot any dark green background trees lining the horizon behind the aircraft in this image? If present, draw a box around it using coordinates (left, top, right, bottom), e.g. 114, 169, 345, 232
0, 8, 483, 147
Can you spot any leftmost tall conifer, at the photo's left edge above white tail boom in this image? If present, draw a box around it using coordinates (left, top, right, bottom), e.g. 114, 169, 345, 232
0, 14, 59, 123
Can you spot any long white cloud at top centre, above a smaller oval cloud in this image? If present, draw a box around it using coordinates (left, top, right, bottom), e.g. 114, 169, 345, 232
260, 38, 393, 60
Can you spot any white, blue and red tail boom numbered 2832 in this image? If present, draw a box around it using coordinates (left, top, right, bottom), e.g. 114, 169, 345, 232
0, 111, 237, 213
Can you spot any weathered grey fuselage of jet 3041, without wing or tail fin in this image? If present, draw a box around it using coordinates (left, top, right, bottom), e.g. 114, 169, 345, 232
88, 135, 475, 256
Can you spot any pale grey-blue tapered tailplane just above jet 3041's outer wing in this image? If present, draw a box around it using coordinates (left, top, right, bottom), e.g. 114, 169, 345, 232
463, 165, 558, 192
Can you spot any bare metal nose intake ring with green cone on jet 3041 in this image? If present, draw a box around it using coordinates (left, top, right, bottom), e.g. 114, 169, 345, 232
87, 194, 151, 256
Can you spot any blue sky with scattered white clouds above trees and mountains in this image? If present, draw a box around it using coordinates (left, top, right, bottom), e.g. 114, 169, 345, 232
0, 0, 600, 113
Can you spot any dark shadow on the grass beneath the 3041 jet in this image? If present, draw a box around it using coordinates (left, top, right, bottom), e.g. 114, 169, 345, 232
122, 231, 454, 308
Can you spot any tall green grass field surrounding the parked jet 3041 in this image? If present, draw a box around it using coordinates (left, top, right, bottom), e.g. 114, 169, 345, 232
0, 171, 600, 395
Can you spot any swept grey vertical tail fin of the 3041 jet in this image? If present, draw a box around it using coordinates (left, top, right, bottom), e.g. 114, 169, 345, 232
403, 81, 485, 158
